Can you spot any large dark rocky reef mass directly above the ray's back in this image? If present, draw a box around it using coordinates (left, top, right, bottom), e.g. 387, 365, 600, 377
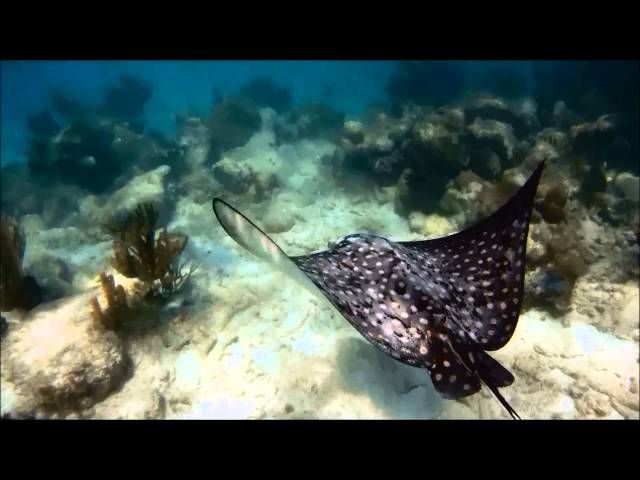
330, 107, 476, 214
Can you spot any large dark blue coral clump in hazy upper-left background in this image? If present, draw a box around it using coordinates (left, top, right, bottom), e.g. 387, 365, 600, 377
27, 76, 182, 193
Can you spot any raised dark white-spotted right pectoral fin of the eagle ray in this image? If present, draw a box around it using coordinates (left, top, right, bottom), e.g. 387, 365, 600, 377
403, 162, 544, 351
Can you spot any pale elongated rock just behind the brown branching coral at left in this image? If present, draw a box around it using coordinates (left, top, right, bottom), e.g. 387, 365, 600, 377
79, 165, 171, 228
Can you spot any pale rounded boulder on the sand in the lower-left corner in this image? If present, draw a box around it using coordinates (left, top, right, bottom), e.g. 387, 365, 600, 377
7, 294, 126, 412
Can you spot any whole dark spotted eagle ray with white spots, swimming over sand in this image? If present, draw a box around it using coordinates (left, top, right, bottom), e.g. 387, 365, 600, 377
213, 161, 544, 419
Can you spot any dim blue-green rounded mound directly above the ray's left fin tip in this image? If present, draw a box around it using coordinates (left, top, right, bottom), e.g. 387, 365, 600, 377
207, 97, 262, 163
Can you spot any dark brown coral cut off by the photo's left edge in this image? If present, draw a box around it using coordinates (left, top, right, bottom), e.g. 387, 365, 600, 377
0, 214, 42, 312
